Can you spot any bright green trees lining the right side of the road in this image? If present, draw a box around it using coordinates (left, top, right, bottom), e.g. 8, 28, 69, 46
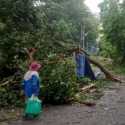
100, 0, 125, 63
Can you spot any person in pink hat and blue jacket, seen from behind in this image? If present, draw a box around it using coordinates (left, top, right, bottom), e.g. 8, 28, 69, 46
23, 62, 41, 98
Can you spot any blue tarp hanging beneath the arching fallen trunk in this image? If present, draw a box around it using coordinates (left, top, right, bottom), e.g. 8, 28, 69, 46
75, 53, 96, 80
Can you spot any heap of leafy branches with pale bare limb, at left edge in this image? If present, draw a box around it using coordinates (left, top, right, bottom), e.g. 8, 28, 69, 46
0, 75, 24, 107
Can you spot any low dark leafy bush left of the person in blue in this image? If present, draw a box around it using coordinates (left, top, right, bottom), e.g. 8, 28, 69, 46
0, 78, 24, 107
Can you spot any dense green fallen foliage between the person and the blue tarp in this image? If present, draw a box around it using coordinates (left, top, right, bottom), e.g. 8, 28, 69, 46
41, 56, 78, 104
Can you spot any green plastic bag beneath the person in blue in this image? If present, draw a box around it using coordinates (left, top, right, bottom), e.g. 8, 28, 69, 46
25, 96, 42, 117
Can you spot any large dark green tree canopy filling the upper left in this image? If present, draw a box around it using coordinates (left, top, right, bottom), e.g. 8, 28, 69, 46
0, 0, 97, 68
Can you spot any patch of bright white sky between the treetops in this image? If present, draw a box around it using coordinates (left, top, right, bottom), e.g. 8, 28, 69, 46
85, 0, 102, 14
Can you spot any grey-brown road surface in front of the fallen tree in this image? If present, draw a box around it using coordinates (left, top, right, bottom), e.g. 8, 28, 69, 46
0, 81, 125, 125
